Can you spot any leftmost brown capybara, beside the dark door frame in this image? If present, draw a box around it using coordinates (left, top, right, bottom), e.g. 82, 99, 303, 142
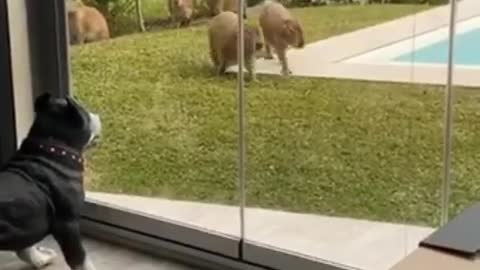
67, 1, 110, 45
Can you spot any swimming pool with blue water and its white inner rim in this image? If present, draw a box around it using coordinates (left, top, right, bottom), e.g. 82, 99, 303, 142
343, 16, 480, 69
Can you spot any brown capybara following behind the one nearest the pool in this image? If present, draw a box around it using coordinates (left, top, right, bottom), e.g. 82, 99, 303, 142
208, 11, 263, 80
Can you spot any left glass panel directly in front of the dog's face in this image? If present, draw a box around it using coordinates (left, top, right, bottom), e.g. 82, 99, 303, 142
69, 0, 240, 241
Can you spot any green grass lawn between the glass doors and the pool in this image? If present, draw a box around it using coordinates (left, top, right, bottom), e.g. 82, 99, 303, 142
72, 5, 480, 228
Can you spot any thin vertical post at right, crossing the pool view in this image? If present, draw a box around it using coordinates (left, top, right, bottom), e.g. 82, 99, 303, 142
441, 0, 457, 226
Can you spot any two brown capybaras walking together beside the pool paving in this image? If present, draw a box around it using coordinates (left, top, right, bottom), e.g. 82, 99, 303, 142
208, 1, 305, 80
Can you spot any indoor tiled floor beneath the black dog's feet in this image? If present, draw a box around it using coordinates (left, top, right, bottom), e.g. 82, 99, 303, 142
0, 237, 199, 270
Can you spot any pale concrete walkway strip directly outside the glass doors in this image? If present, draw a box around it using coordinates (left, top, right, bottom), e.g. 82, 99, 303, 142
87, 192, 433, 270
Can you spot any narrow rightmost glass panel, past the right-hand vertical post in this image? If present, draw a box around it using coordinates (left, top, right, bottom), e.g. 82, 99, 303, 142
449, 1, 480, 219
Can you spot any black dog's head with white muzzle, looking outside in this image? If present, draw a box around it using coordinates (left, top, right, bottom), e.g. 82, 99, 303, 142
29, 94, 101, 152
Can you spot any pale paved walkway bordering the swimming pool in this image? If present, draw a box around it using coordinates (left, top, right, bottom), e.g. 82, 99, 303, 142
234, 0, 480, 86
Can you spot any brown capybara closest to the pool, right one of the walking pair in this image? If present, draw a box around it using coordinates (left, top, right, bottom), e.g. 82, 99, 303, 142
259, 1, 305, 75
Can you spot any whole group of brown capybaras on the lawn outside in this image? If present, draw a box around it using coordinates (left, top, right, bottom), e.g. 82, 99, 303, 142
67, 0, 305, 80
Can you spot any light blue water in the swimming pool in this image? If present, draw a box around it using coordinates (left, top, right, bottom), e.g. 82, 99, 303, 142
394, 28, 480, 66
